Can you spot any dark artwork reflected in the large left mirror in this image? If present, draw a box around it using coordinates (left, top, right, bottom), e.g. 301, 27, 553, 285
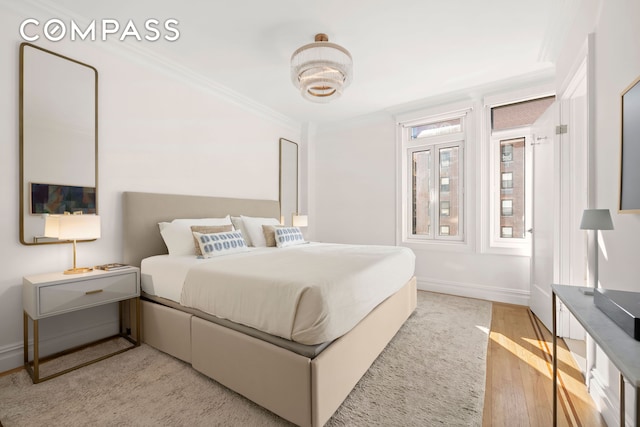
31, 183, 96, 214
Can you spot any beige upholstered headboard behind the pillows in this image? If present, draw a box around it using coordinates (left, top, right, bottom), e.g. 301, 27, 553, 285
122, 192, 280, 267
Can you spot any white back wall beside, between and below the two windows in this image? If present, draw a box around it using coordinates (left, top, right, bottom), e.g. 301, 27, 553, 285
310, 104, 530, 305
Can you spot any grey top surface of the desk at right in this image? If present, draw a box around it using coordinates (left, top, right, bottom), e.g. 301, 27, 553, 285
551, 285, 640, 387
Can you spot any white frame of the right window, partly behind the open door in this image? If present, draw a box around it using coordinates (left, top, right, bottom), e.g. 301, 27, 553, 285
479, 84, 555, 256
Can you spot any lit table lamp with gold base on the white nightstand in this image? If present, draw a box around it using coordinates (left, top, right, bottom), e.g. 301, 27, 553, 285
44, 212, 100, 274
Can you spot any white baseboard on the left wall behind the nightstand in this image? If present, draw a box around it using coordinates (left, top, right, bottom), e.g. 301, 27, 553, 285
0, 320, 118, 374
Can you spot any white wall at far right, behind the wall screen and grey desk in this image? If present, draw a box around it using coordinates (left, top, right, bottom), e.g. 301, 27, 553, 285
557, 0, 640, 425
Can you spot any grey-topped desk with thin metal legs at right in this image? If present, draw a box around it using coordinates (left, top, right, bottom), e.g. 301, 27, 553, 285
551, 285, 640, 427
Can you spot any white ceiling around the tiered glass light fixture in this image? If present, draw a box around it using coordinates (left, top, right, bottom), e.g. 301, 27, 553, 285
41, 0, 580, 123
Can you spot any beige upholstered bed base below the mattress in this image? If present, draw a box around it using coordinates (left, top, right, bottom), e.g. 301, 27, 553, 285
142, 278, 417, 427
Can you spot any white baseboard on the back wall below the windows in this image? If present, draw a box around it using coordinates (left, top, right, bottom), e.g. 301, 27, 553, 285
417, 277, 529, 306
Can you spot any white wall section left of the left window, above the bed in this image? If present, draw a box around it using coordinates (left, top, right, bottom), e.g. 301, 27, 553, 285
311, 114, 396, 245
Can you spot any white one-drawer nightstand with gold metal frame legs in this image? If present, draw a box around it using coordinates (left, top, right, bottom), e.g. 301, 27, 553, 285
22, 267, 140, 383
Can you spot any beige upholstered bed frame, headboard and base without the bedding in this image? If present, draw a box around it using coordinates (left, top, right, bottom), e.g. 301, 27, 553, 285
123, 192, 416, 426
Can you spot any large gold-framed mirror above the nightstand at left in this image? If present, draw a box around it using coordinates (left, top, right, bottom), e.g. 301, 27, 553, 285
19, 43, 98, 245
